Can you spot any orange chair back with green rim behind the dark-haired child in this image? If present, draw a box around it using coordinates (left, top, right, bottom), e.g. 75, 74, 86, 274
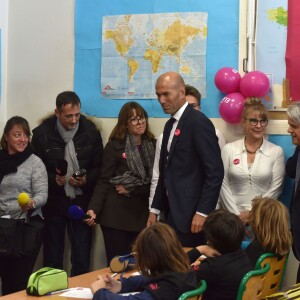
237, 263, 270, 300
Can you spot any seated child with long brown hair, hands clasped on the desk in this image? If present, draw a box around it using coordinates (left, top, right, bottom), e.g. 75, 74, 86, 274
91, 222, 199, 300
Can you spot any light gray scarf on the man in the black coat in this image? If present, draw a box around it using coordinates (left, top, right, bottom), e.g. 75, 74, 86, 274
56, 119, 82, 199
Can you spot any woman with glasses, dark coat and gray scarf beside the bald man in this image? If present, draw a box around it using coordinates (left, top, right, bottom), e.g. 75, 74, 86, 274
87, 102, 155, 264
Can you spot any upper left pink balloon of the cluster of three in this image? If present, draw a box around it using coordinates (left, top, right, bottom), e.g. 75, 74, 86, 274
215, 67, 241, 94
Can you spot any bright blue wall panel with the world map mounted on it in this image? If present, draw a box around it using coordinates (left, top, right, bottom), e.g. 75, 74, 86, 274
74, 0, 239, 118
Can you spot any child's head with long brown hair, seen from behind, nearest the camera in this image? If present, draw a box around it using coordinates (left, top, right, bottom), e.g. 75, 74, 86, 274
133, 222, 190, 277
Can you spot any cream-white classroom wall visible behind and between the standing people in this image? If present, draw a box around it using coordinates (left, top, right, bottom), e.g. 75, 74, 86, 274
0, 0, 297, 284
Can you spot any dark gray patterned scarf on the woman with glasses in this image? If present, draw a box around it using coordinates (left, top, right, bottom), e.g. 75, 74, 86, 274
110, 133, 155, 192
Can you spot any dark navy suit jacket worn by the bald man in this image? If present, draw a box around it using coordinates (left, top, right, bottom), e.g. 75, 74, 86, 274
152, 105, 224, 233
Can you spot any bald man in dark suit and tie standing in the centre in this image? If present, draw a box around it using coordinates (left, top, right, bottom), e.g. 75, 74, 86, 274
147, 72, 224, 247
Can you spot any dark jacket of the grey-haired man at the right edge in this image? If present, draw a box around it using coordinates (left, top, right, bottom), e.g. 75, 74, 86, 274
285, 147, 300, 260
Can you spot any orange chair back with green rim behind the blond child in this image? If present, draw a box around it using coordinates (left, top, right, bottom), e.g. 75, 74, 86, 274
255, 253, 289, 298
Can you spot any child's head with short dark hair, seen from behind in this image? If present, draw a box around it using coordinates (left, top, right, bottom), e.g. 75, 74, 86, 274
203, 209, 245, 254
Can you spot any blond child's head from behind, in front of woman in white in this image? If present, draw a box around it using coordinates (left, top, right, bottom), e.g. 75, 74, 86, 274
250, 197, 292, 255
